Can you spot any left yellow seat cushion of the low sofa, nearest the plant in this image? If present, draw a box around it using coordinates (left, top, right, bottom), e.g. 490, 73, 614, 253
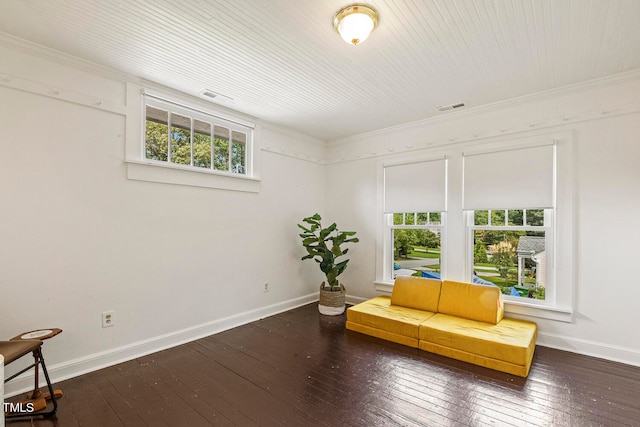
347, 296, 435, 348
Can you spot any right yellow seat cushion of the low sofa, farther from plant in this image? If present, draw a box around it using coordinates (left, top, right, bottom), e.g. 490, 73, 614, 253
420, 313, 538, 371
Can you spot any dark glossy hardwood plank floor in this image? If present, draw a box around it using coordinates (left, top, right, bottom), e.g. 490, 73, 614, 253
7, 304, 640, 427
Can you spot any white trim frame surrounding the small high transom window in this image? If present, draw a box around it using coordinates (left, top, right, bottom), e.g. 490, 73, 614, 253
125, 84, 261, 193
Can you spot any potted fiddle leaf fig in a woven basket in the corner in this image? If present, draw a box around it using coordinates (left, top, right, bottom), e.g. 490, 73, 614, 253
298, 214, 359, 315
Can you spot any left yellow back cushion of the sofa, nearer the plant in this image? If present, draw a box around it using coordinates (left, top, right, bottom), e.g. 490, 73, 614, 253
391, 276, 442, 313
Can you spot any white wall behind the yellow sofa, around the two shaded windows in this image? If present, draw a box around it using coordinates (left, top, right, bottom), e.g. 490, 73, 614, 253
327, 74, 640, 365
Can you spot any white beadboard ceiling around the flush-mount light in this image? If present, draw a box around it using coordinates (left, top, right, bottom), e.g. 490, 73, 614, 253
0, 0, 640, 141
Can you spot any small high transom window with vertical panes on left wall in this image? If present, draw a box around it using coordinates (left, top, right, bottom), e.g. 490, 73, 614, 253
144, 96, 253, 175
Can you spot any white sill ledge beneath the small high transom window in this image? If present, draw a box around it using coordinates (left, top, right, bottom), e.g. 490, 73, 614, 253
125, 160, 260, 193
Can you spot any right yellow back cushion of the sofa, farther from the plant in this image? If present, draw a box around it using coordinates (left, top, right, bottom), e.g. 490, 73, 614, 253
438, 280, 504, 325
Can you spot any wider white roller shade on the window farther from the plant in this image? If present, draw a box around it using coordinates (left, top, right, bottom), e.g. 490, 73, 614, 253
463, 145, 554, 210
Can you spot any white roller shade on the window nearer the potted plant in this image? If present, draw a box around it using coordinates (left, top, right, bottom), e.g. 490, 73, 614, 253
384, 159, 447, 213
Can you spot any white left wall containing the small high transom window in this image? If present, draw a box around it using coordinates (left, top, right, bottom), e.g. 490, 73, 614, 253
0, 42, 325, 394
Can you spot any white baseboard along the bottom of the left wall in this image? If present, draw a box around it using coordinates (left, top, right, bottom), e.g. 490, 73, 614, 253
4, 292, 318, 397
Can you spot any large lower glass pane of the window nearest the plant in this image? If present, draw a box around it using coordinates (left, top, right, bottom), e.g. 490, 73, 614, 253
392, 229, 440, 278
